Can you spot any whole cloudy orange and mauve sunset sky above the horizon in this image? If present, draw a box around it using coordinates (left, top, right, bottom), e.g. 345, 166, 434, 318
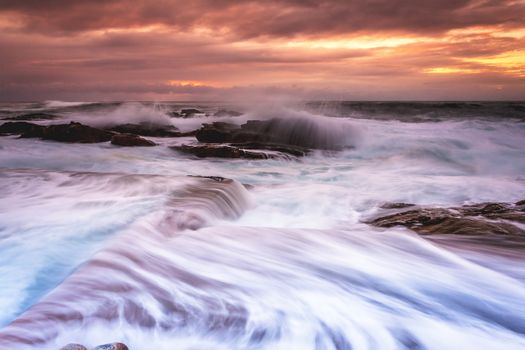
0, 0, 525, 101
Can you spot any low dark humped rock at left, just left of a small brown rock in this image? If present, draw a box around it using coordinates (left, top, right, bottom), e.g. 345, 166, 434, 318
22, 122, 114, 143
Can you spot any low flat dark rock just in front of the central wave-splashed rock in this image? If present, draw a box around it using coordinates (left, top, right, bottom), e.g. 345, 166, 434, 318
172, 145, 279, 159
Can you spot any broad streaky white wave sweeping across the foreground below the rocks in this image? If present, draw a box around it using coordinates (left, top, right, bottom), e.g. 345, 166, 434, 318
0, 223, 525, 350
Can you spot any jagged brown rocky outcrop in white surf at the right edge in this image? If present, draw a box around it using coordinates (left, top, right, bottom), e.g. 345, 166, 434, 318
365, 201, 525, 236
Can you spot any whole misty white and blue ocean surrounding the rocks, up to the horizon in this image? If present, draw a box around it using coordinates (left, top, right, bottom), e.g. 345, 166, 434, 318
0, 101, 525, 350
